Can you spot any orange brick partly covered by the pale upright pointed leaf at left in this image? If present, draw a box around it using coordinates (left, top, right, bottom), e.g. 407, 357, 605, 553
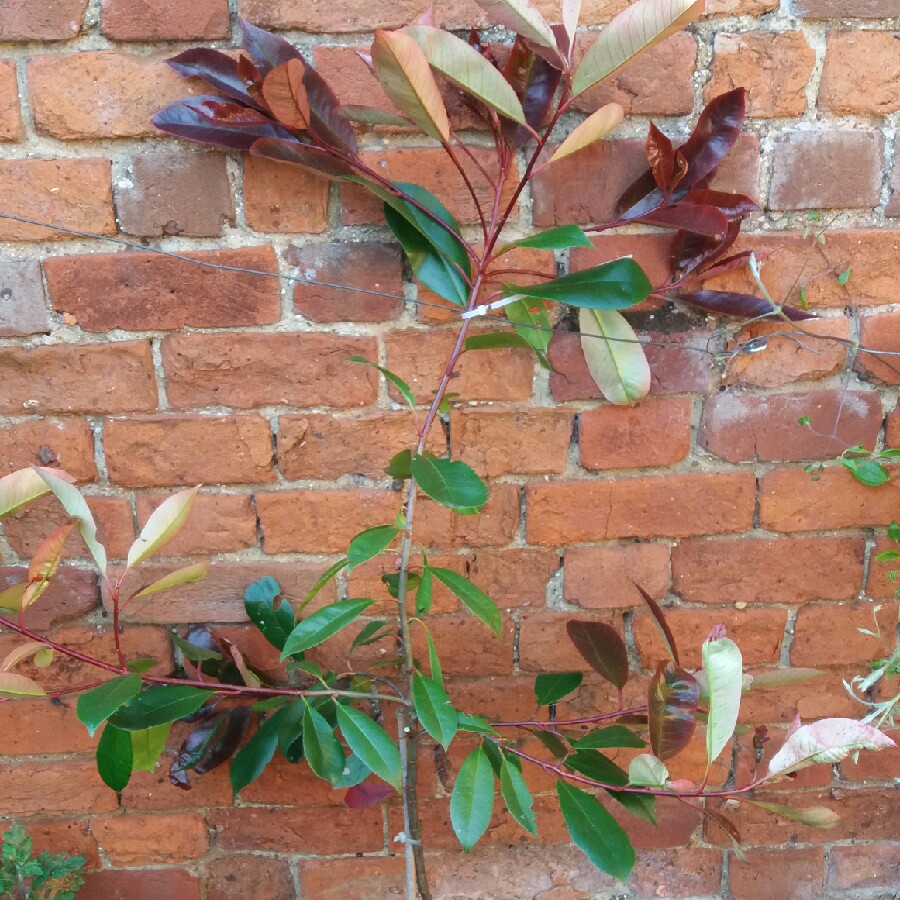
137, 494, 257, 556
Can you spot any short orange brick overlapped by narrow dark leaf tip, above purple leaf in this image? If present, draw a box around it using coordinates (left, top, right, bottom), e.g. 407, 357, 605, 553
563, 543, 671, 609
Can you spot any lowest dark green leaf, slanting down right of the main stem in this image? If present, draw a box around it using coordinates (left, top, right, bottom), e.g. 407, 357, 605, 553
556, 780, 634, 882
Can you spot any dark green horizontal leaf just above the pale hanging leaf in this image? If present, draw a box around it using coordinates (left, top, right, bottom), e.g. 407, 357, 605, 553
503, 258, 653, 310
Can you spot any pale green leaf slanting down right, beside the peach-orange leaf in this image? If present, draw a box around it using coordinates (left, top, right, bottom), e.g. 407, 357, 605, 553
404, 25, 525, 125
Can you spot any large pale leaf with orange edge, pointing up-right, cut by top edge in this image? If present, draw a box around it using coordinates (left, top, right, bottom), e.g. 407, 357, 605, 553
572, 0, 703, 96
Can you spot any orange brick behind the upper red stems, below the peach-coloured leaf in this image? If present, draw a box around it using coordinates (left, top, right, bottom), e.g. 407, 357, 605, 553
341, 147, 517, 225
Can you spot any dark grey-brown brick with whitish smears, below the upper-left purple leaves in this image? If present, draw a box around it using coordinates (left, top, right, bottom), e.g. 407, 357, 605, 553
116, 151, 234, 237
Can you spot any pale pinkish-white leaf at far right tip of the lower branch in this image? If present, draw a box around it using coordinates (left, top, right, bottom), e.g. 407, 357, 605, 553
768, 719, 896, 778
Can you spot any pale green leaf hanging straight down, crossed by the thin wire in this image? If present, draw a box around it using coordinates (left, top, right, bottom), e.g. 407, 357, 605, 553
578, 309, 650, 406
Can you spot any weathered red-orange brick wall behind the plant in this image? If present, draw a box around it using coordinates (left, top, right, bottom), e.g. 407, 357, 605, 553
0, 0, 900, 900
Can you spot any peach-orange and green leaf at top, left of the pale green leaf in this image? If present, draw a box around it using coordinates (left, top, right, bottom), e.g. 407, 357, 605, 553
372, 31, 450, 143
